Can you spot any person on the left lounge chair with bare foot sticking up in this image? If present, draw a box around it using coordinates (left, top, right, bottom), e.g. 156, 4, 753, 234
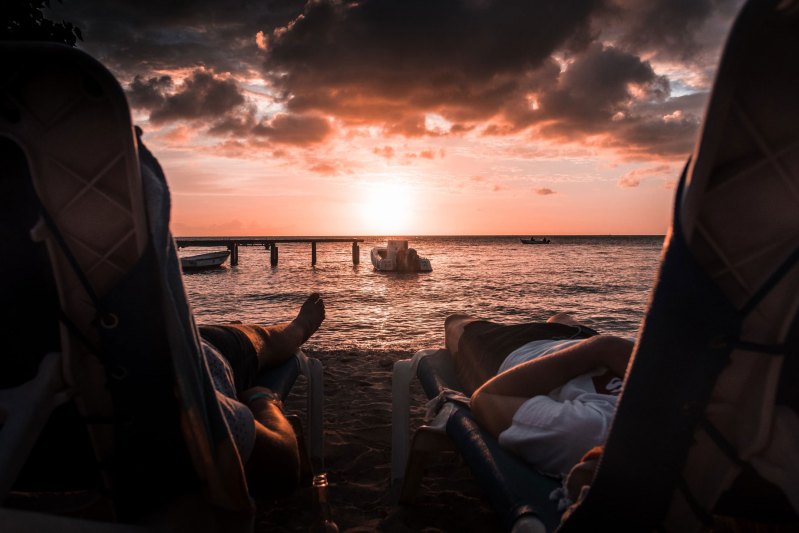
199, 293, 325, 496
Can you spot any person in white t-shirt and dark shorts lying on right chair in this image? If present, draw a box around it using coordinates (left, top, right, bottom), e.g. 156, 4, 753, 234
445, 313, 633, 475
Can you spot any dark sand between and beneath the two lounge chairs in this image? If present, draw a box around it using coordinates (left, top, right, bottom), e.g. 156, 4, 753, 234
256, 351, 506, 532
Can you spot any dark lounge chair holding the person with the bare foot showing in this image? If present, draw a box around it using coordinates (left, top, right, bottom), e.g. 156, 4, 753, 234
0, 43, 323, 531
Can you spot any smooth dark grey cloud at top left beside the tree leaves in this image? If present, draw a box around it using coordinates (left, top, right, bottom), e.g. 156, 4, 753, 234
51, 0, 304, 78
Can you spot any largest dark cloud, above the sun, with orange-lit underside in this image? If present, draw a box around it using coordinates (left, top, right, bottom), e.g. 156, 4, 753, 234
266, 0, 599, 131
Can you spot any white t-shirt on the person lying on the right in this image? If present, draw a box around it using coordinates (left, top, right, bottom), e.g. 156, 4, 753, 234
499, 339, 621, 474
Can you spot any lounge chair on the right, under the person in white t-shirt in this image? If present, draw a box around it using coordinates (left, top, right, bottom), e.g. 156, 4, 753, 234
392, 1, 799, 532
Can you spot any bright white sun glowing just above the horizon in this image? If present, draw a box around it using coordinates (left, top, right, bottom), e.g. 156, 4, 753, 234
361, 181, 414, 235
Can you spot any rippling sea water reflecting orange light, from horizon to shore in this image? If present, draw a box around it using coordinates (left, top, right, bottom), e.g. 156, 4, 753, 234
180, 236, 663, 351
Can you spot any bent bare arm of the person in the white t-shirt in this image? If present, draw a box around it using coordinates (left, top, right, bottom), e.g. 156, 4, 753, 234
471, 335, 633, 436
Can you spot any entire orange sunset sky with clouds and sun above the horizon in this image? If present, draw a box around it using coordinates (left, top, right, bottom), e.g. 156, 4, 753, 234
47, 0, 741, 236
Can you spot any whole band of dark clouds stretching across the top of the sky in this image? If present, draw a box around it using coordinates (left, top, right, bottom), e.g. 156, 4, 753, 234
47, 0, 742, 157
